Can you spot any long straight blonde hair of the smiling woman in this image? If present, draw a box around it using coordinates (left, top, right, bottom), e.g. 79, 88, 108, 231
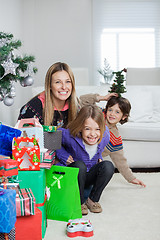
43, 62, 77, 125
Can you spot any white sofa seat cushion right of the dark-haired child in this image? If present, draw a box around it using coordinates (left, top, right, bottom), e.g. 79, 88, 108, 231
118, 122, 160, 142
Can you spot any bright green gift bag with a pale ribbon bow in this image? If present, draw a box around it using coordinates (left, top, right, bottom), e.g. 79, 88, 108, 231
46, 165, 82, 222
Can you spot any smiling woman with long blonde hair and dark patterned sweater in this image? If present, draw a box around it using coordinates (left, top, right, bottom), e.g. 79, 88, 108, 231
18, 62, 80, 127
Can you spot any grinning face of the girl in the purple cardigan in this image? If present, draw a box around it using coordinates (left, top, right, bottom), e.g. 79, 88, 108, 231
82, 117, 101, 145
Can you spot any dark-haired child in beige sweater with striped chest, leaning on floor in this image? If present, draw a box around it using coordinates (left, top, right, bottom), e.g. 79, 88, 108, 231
80, 94, 146, 187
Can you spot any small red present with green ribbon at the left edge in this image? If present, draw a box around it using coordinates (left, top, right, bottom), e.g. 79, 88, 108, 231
0, 158, 18, 177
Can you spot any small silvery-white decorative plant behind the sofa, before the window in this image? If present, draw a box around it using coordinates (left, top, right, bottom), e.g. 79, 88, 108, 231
98, 58, 113, 84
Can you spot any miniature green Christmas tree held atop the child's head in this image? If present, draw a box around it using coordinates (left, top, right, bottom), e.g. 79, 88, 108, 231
108, 68, 127, 97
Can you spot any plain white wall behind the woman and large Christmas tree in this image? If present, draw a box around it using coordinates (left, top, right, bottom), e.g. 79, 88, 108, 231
0, 0, 93, 126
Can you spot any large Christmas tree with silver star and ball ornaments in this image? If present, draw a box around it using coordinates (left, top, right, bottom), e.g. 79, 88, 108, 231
0, 32, 37, 106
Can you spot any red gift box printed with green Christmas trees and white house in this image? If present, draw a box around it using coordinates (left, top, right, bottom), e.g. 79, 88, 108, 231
12, 137, 40, 170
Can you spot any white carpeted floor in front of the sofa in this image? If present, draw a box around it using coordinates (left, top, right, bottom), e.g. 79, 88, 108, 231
44, 173, 160, 240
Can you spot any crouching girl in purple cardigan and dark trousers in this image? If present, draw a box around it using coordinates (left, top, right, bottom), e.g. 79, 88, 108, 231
56, 105, 114, 215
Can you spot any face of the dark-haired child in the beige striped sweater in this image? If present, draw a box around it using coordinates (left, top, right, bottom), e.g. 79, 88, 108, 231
106, 103, 123, 125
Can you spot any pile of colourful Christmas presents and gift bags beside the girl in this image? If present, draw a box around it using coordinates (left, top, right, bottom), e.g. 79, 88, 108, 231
0, 118, 93, 240
